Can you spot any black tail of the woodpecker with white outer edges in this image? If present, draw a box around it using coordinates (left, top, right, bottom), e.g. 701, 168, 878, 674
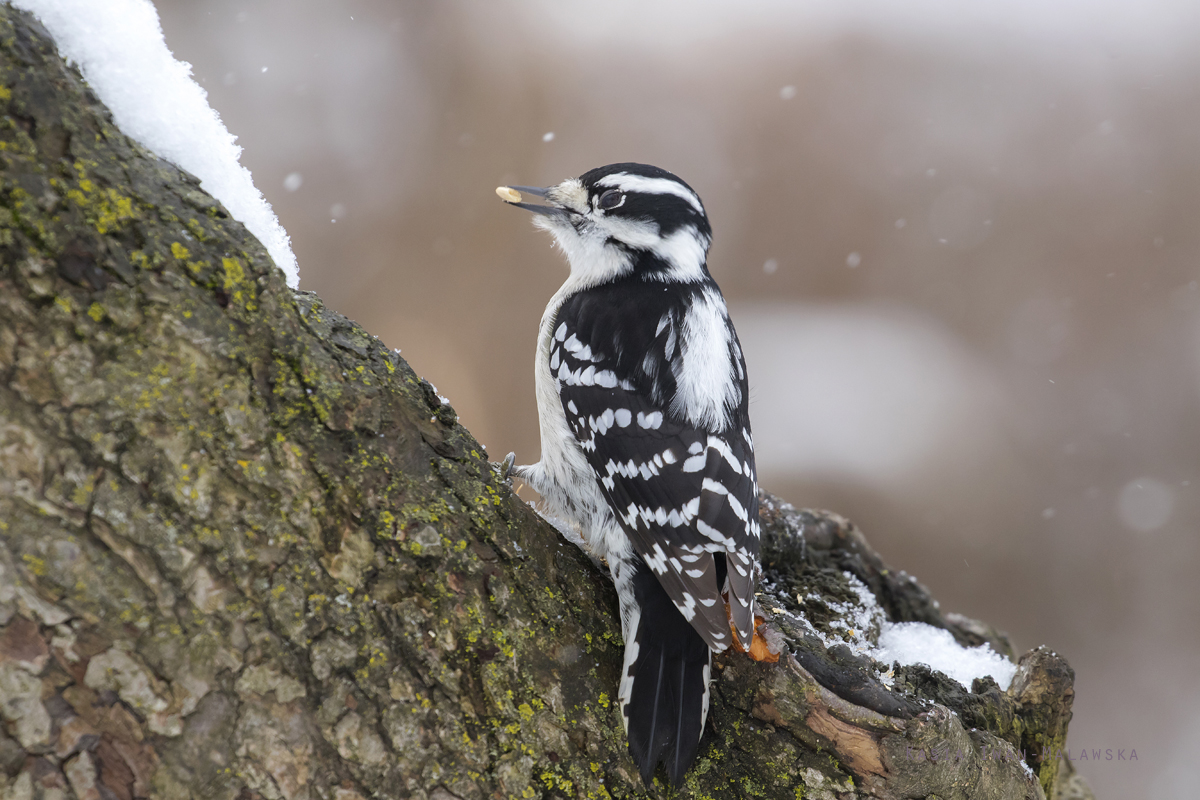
618, 564, 710, 786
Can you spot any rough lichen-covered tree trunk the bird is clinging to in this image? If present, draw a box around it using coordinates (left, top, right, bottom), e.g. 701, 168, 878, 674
0, 6, 1090, 800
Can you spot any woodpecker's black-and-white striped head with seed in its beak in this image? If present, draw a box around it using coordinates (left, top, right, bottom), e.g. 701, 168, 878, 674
496, 163, 713, 285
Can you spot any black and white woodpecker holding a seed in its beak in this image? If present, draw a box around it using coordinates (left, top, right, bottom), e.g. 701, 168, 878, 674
497, 163, 760, 786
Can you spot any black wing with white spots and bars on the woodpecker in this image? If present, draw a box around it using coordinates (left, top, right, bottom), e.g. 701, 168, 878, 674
550, 287, 758, 651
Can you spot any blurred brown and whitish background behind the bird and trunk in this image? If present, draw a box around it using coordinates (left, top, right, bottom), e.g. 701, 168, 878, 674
156, 0, 1200, 799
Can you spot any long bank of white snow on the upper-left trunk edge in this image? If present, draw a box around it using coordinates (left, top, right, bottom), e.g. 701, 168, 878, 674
12, 0, 300, 288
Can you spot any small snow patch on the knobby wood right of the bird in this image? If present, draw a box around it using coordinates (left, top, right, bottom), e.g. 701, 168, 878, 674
871, 622, 1016, 688
